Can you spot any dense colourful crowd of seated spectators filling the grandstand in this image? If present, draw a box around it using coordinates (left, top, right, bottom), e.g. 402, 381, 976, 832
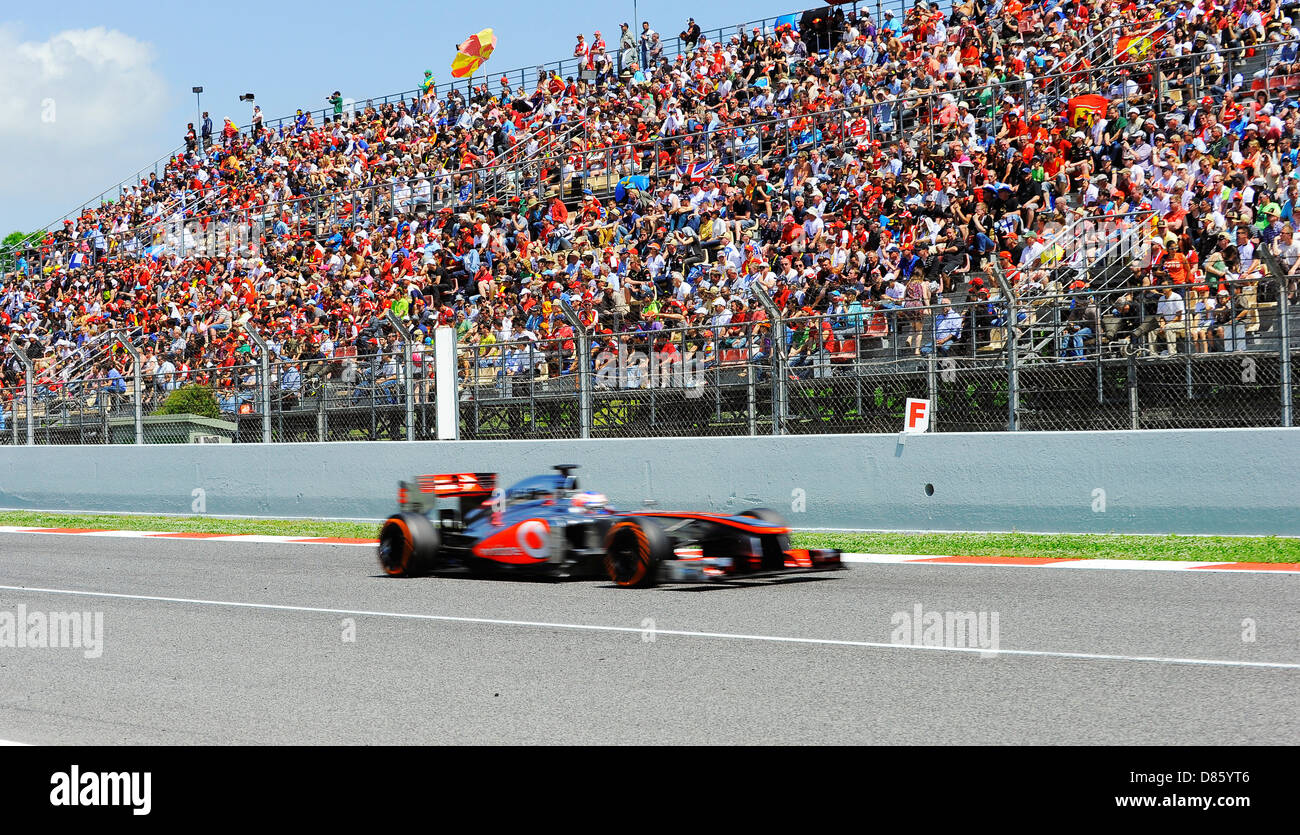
0, 0, 1300, 416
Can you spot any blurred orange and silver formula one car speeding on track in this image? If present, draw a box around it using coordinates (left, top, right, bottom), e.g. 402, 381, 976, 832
380, 464, 844, 588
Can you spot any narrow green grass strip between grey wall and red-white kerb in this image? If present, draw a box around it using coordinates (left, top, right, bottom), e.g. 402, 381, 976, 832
0, 511, 1300, 562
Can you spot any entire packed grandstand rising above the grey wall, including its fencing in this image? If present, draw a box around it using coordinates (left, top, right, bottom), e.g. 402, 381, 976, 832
0, 0, 1300, 444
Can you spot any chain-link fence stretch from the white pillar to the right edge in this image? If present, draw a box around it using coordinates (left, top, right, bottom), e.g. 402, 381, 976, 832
447, 281, 1295, 438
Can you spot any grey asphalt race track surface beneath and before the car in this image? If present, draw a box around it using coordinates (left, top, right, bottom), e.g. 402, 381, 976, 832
0, 535, 1300, 745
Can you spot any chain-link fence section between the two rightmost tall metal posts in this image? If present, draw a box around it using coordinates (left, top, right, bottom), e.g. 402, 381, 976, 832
1017, 274, 1296, 429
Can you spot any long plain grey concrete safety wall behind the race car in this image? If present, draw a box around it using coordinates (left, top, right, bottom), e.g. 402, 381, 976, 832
0, 429, 1300, 536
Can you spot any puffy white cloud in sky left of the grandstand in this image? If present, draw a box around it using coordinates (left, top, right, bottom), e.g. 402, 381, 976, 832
0, 26, 169, 235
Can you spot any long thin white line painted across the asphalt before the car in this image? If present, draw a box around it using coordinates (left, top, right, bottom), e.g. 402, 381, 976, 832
0, 585, 1300, 670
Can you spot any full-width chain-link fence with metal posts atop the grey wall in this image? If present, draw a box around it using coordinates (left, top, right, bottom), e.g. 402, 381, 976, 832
0, 277, 1297, 445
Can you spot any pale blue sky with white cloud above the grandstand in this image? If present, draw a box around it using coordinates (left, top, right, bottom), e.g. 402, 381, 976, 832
0, 0, 797, 237
